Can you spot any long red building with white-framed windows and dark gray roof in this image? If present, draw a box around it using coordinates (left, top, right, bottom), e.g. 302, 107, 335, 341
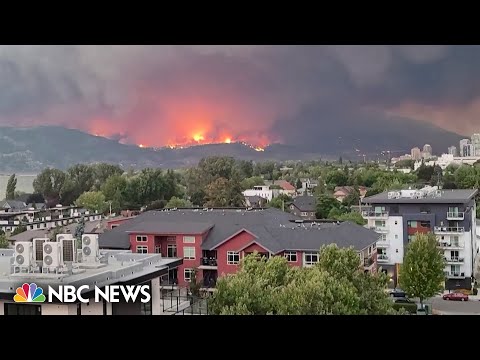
99, 208, 379, 288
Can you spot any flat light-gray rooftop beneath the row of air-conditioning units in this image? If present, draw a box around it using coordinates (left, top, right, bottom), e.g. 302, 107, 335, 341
0, 249, 182, 294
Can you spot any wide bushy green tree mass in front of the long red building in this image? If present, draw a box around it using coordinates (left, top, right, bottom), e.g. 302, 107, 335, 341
209, 245, 396, 315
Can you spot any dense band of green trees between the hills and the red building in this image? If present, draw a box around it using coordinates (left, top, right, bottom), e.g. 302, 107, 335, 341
13, 156, 480, 218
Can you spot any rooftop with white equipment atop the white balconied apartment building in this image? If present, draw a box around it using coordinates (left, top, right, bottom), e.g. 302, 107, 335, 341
362, 186, 478, 204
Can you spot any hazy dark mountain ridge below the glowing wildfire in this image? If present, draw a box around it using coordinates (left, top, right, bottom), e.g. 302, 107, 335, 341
0, 124, 462, 174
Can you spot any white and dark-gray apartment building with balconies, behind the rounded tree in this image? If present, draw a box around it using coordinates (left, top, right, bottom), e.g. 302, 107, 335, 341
363, 187, 478, 289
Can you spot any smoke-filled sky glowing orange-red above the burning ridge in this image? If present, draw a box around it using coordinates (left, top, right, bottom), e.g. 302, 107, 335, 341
0, 45, 480, 146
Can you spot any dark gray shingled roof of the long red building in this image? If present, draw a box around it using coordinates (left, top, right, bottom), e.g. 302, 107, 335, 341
99, 208, 378, 253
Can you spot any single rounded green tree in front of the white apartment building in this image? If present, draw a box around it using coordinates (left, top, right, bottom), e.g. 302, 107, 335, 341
399, 233, 445, 307
